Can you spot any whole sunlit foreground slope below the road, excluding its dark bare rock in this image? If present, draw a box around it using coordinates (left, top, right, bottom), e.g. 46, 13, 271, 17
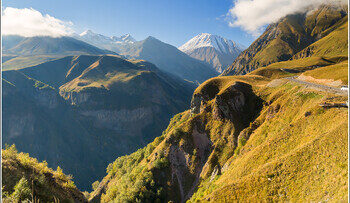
92, 73, 348, 202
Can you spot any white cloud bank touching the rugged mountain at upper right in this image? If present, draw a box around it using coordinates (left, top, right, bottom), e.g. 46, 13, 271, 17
228, 0, 347, 35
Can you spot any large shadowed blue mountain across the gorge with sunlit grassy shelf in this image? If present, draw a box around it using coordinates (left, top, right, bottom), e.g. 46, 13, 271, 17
2, 55, 195, 190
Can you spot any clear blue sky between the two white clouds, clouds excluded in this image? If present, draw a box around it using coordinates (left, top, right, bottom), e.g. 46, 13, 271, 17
2, 0, 255, 46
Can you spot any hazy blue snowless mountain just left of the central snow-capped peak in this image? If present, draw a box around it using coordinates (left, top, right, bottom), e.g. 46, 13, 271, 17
120, 37, 218, 83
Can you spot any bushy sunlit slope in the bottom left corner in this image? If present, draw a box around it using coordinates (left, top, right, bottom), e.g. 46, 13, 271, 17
1, 145, 86, 202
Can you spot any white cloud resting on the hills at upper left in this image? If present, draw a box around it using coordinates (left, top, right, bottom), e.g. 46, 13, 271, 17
1, 7, 73, 37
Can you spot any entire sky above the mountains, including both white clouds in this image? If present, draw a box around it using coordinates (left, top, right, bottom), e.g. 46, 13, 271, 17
1, 0, 347, 47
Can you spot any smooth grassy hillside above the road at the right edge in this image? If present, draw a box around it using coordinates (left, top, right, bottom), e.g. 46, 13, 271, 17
248, 16, 348, 84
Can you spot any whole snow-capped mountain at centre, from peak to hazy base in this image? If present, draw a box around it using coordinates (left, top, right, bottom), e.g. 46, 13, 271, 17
179, 33, 245, 73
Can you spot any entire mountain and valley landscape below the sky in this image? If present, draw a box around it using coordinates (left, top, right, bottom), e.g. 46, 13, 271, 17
2, 4, 349, 203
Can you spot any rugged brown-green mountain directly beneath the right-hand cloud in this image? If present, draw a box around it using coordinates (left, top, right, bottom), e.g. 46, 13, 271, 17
223, 6, 347, 75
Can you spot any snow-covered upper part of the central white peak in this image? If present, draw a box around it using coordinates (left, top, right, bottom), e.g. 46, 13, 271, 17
179, 33, 244, 53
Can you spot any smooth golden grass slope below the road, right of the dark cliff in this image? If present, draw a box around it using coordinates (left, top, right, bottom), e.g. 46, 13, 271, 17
191, 84, 348, 202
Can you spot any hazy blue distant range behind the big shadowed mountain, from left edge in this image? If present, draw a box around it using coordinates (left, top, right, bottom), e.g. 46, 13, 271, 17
3, 30, 218, 82
